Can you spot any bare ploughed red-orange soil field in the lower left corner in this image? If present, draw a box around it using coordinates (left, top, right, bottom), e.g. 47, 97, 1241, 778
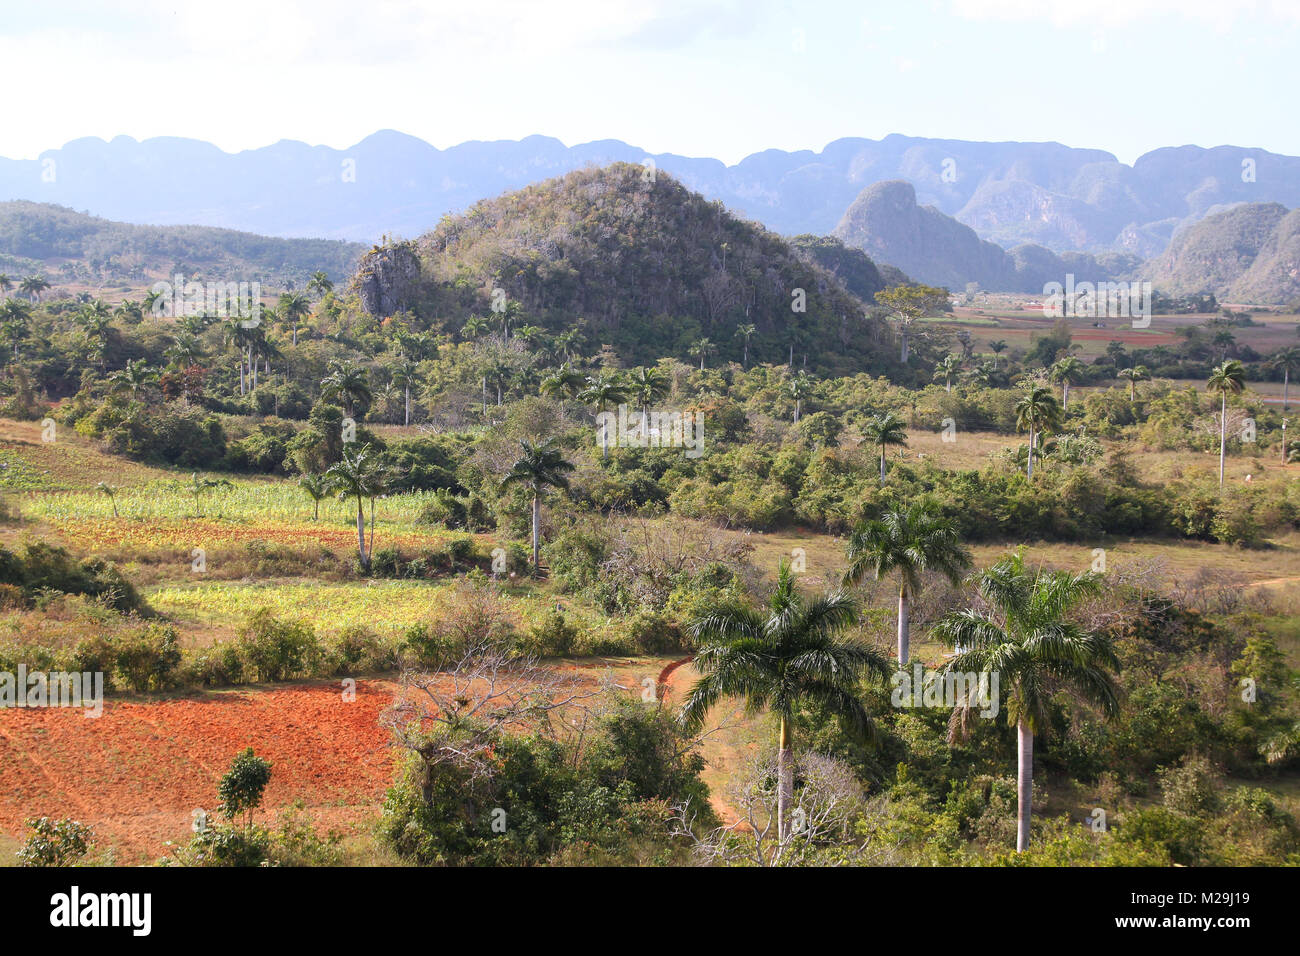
0, 680, 397, 864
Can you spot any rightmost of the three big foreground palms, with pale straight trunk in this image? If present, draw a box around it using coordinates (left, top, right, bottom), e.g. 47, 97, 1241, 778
932, 554, 1119, 852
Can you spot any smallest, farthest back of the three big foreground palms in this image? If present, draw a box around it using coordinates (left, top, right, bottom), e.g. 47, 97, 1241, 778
844, 501, 971, 667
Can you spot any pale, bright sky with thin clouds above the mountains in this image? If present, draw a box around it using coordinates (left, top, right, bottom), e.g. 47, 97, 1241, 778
0, 0, 1300, 164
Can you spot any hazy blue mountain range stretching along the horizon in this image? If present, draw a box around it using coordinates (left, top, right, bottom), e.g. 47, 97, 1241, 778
0, 130, 1300, 256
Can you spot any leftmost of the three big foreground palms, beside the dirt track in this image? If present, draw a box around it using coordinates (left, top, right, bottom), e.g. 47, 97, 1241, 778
681, 562, 889, 844
